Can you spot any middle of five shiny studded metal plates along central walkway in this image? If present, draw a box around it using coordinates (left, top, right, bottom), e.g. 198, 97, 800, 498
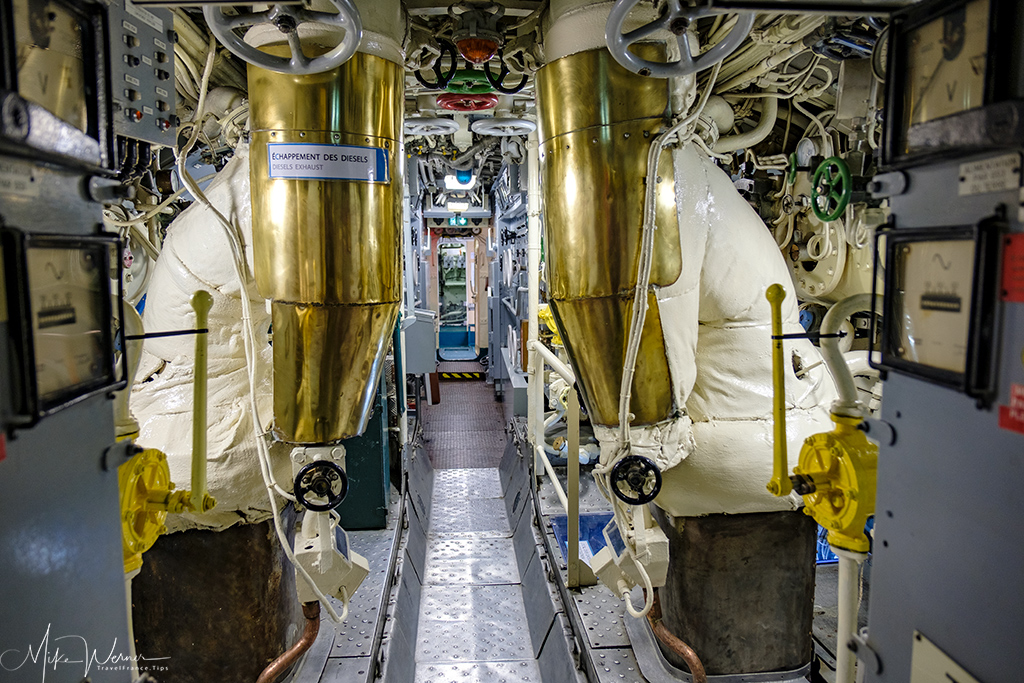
423, 537, 519, 586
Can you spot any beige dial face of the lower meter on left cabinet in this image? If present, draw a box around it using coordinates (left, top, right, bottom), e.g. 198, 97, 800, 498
27, 245, 113, 407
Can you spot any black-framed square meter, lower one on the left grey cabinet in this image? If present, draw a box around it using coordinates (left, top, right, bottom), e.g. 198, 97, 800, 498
0, 228, 124, 425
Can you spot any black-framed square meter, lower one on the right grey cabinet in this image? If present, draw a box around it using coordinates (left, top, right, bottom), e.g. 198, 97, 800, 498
872, 219, 1001, 399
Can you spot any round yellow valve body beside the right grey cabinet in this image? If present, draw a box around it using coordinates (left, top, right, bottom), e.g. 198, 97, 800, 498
793, 415, 879, 553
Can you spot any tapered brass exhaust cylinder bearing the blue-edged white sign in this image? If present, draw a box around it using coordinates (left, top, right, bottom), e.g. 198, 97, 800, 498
249, 52, 404, 443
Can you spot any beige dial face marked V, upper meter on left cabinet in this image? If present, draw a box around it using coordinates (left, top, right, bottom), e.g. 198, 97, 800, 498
14, 0, 89, 132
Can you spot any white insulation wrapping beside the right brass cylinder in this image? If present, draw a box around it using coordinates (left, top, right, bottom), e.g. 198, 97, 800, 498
596, 144, 836, 516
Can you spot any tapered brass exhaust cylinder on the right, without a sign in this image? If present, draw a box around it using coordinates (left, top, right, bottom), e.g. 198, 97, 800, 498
537, 46, 682, 426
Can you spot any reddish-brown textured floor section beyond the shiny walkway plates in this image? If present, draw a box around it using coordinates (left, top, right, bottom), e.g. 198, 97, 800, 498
423, 381, 505, 470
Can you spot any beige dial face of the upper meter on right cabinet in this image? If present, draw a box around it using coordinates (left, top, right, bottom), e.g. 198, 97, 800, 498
903, 0, 989, 144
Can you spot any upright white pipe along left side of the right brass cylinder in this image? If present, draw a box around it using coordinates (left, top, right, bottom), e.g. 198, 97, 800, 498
526, 131, 544, 454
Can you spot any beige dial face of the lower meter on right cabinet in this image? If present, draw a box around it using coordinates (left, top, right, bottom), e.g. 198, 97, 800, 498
895, 240, 975, 373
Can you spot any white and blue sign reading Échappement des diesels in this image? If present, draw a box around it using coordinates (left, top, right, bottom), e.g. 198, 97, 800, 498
267, 142, 391, 182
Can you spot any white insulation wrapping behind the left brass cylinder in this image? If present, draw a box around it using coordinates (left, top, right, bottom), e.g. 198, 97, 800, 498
131, 146, 288, 531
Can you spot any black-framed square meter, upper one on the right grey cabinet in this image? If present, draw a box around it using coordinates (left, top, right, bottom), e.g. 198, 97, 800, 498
884, 0, 1024, 167
